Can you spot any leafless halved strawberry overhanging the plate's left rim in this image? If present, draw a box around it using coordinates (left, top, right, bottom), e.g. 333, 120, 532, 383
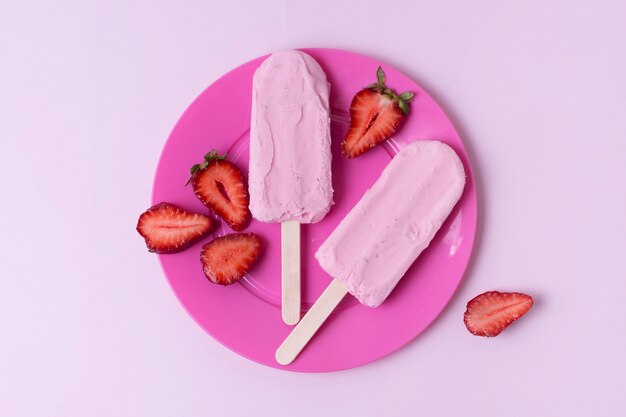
137, 203, 212, 253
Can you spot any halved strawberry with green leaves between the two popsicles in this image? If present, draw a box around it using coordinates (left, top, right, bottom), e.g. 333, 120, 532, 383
341, 67, 414, 158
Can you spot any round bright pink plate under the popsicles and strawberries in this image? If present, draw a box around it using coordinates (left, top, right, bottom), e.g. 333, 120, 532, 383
152, 49, 476, 372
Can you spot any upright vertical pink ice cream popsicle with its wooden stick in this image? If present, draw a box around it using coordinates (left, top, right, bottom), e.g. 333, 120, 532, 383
249, 50, 333, 324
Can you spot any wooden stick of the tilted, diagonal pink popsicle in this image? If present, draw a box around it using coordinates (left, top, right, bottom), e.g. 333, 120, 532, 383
276, 279, 348, 365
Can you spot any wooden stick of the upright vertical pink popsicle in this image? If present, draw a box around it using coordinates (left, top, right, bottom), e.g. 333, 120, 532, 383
281, 220, 300, 325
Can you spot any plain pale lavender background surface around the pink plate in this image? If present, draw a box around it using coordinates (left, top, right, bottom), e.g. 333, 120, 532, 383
0, 0, 626, 417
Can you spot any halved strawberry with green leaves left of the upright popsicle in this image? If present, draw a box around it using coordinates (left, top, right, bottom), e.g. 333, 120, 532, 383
187, 151, 250, 231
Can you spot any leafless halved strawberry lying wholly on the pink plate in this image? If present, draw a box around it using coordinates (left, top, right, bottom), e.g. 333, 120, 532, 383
200, 233, 261, 285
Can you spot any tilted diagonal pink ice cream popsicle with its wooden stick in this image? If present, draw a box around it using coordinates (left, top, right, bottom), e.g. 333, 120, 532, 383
276, 141, 465, 365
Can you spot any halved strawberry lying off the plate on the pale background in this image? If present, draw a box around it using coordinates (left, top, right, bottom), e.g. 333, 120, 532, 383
463, 291, 533, 337
